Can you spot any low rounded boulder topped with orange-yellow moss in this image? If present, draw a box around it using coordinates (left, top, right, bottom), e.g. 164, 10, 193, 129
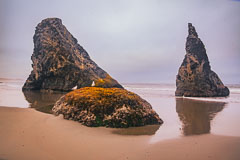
52, 87, 163, 128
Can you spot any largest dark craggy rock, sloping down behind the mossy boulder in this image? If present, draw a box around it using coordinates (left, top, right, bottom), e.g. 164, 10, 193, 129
23, 18, 122, 91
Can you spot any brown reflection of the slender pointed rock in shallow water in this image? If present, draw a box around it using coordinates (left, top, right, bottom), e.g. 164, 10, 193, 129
176, 98, 226, 135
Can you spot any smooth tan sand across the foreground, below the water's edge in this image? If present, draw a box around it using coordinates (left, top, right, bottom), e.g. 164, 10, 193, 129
0, 107, 240, 160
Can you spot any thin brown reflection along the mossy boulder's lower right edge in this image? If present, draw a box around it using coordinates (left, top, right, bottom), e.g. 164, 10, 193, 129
112, 125, 160, 136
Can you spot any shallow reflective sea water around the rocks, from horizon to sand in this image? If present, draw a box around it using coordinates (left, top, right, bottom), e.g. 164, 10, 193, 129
0, 79, 240, 143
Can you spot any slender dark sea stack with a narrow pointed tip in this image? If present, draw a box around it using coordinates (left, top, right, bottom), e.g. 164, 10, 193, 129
175, 23, 229, 97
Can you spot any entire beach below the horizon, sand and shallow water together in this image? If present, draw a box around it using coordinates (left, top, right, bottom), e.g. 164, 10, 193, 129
0, 80, 240, 160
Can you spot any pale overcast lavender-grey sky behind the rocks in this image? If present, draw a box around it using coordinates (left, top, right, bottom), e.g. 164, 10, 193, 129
0, 0, 240, 84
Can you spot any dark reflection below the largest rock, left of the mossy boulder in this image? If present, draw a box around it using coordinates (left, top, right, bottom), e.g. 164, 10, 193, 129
23, 91, 66, 113
